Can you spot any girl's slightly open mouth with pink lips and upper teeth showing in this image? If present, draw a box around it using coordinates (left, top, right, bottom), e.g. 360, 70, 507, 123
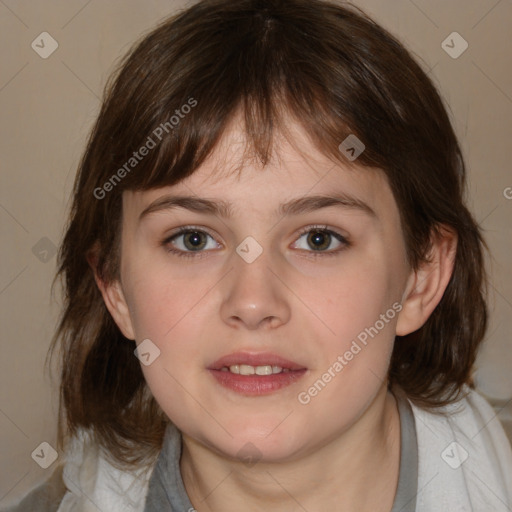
208, 352, 308, 396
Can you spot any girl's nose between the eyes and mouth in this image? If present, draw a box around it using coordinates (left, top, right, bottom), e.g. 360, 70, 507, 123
221, 245, 291, 330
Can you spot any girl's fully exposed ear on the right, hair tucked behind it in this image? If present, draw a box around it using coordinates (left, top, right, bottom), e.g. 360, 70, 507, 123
396, 225, 457, 336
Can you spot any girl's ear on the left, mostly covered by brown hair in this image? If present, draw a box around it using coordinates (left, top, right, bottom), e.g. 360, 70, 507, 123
87, 244, 135, 340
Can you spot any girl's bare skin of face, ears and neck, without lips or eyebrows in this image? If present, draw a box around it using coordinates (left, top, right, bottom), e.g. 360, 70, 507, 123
97, 113, 456, 512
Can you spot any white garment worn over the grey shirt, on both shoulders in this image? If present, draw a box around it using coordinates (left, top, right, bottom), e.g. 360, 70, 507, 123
58, 386, 512, 512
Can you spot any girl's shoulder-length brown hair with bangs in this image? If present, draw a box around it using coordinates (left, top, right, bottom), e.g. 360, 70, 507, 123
50, 0, 487, 466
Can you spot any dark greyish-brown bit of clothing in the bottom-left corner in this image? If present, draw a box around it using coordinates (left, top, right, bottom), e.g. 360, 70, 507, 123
1, 464, 67, 512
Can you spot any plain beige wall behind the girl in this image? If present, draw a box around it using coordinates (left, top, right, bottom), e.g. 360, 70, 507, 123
0, 0, 512, 507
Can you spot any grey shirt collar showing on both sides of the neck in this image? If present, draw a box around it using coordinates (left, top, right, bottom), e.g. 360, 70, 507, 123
144, 388, 418, 512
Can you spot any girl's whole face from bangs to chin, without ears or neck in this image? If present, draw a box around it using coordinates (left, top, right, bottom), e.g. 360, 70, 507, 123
107, 116, 408, 461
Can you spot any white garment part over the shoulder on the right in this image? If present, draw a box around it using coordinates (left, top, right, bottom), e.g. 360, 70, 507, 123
411, 386, 512, 512
